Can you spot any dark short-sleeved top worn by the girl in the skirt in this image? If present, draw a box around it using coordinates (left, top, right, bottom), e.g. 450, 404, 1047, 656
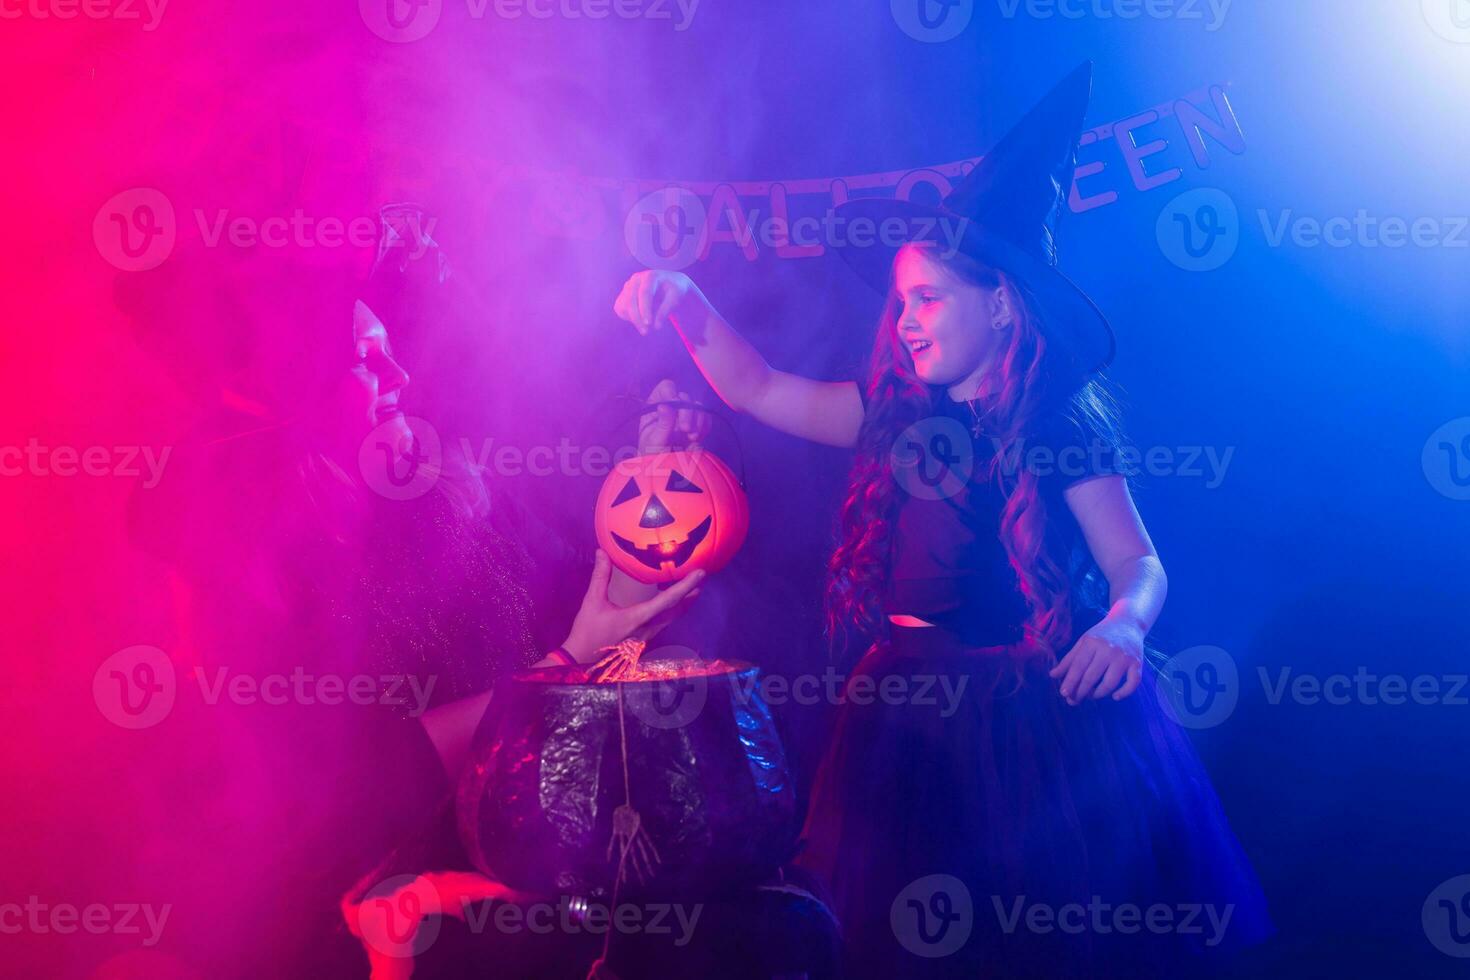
885, 392, 1122, 646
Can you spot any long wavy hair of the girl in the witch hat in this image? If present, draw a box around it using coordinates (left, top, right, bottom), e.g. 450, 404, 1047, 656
825, 244, 1119, 657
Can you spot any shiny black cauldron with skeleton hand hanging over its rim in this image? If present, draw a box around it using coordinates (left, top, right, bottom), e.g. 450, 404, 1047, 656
457, 661, 797, 898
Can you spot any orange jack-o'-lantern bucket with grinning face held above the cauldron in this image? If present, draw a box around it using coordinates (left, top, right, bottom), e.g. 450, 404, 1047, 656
594, 450, 750, 585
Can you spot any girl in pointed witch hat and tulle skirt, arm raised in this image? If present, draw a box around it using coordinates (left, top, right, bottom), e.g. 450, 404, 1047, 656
614, 65, 1270, 977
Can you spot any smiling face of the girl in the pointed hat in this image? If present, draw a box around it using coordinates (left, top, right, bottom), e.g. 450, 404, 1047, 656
894, 245, 1013, 398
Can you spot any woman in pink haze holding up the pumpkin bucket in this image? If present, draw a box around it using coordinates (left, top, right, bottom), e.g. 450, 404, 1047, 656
118, 243, 704, 977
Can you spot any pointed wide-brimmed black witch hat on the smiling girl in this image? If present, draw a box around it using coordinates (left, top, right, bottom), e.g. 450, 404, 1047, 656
836, 62, 1114, 381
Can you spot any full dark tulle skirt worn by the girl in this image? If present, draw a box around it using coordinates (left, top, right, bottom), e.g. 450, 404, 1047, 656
798, 627, 1272, 979
